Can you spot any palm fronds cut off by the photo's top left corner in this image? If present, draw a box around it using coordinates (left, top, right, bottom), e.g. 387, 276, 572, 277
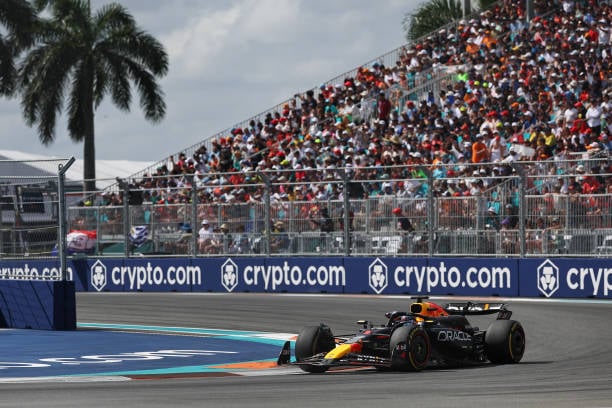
0, 0, 36, 95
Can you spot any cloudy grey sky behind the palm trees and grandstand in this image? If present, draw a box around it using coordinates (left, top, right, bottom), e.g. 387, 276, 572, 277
0, 0, 420, 162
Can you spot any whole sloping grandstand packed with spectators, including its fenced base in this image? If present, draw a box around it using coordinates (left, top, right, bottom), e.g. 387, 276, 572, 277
64, 0, 612, 256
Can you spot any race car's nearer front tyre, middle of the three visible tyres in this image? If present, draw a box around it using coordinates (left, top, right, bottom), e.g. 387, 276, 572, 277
389, 326, 431, 371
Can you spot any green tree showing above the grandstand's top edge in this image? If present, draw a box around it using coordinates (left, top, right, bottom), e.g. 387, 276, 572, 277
402, 0, 496, 41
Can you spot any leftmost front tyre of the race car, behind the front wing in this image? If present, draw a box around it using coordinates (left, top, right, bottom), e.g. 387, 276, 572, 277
295, 324, 336, 373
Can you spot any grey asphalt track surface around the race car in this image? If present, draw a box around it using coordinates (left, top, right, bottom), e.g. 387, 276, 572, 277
0, 293, 612, 408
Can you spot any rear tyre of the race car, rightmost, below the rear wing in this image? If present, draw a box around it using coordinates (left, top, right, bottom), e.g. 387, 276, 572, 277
485, 320, 525, 364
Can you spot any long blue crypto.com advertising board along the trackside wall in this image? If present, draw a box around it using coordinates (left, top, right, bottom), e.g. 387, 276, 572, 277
0, 257, 612, 298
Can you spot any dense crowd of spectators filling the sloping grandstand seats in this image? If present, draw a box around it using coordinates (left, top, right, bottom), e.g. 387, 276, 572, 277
99, 0, 612, 230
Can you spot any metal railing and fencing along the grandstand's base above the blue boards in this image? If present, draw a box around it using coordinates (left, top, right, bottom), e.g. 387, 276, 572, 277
68, 157, 612, 257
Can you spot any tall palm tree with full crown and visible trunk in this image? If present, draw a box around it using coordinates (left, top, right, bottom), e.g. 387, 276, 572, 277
19, 0, 168, 191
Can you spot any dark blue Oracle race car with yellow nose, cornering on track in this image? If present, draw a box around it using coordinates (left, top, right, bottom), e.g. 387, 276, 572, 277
278, 296, 525, 373
